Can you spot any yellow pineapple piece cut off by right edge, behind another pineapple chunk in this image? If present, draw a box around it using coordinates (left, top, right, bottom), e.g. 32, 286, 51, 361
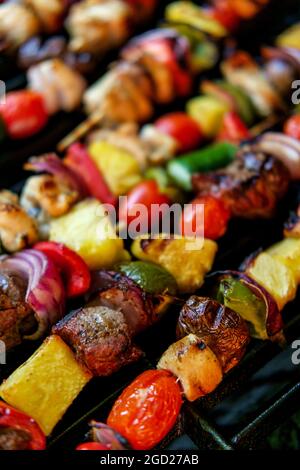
267, 238, 300, 284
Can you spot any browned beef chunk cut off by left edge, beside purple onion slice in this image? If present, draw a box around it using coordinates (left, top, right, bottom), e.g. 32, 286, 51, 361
0, 270, 36, 350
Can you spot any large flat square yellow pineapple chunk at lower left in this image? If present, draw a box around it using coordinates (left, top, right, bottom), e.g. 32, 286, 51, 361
0, 336, 92, 436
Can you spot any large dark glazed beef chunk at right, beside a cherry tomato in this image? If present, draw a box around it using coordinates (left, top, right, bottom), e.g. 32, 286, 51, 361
193, 146, 290, 219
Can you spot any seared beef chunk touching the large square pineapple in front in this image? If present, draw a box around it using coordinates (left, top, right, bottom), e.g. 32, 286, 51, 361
52, 306, 142, 376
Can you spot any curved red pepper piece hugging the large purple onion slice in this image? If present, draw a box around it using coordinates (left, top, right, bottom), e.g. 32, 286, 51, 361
34, 242, 91, 297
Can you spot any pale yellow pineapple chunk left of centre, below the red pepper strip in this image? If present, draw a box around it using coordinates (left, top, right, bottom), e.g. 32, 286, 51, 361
50, 199, 129, 270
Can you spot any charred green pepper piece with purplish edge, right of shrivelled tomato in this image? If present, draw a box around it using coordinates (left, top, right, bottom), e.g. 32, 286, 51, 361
217, 272, 283, 340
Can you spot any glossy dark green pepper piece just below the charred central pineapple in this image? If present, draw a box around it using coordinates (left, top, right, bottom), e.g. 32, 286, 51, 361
117, 261, 177, 295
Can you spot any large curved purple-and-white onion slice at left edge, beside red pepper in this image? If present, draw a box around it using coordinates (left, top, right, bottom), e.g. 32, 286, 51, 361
0, 249, 65, 340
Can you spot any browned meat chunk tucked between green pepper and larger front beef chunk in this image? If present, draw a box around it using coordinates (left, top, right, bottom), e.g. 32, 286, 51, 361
88, 271, 159, 336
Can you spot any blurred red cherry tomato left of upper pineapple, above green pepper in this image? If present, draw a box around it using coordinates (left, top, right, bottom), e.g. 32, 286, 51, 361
155, 112, 203, 153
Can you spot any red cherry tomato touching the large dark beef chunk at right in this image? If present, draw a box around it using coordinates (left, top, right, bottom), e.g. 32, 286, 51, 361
181, 195, 230, 240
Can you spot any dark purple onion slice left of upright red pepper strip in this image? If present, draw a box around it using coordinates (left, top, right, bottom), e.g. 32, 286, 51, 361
25, 153, 89, 197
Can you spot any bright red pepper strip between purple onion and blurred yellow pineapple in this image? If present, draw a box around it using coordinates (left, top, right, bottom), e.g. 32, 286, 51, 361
64, 142, 117, 206
